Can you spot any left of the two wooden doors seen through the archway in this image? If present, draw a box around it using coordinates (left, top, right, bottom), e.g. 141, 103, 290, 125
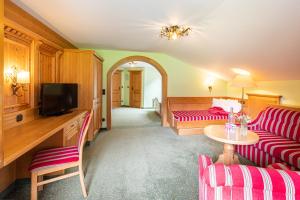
112, 70, 122, 108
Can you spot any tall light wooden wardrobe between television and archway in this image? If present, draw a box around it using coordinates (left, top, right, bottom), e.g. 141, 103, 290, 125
59, 49, 103, 141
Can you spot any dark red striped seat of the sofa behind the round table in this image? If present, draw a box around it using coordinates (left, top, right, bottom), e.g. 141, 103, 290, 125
254, 131, 300, 168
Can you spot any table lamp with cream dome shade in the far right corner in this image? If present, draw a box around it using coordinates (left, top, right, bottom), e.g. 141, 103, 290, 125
230, 74, 256, 112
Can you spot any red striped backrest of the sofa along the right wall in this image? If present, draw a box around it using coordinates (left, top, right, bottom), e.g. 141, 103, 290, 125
260, 107, 300, 142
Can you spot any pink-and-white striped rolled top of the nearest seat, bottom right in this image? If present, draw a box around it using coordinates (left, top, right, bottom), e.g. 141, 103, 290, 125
202, 164, 300, 196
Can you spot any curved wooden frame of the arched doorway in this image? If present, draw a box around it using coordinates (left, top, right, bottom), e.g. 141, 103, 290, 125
106, 56, 168, 129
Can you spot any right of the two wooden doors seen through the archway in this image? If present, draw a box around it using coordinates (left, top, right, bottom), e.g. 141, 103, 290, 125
129, 71, 142, 108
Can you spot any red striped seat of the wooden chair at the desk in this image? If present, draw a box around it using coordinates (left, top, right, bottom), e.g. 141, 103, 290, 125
29, 146, 79, 171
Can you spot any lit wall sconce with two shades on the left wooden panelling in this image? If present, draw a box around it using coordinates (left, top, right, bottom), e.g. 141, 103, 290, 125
5, 66, 30, 97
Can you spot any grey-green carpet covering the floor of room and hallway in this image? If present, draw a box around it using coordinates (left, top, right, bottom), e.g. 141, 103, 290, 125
4, 108, 254, 200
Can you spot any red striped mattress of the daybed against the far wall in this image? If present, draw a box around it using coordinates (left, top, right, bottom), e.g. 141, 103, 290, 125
172, 110, 228, 122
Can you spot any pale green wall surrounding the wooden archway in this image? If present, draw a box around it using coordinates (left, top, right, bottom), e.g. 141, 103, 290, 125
94, 49, 227, 127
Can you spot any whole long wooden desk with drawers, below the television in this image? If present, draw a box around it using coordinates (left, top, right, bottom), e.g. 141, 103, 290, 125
0, 110, 86, 192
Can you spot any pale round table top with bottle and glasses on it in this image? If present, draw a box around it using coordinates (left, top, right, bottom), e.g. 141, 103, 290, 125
204, 125, 259, 145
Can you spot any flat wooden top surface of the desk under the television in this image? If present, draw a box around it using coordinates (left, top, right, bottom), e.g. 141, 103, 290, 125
3, 111, 85, 166
